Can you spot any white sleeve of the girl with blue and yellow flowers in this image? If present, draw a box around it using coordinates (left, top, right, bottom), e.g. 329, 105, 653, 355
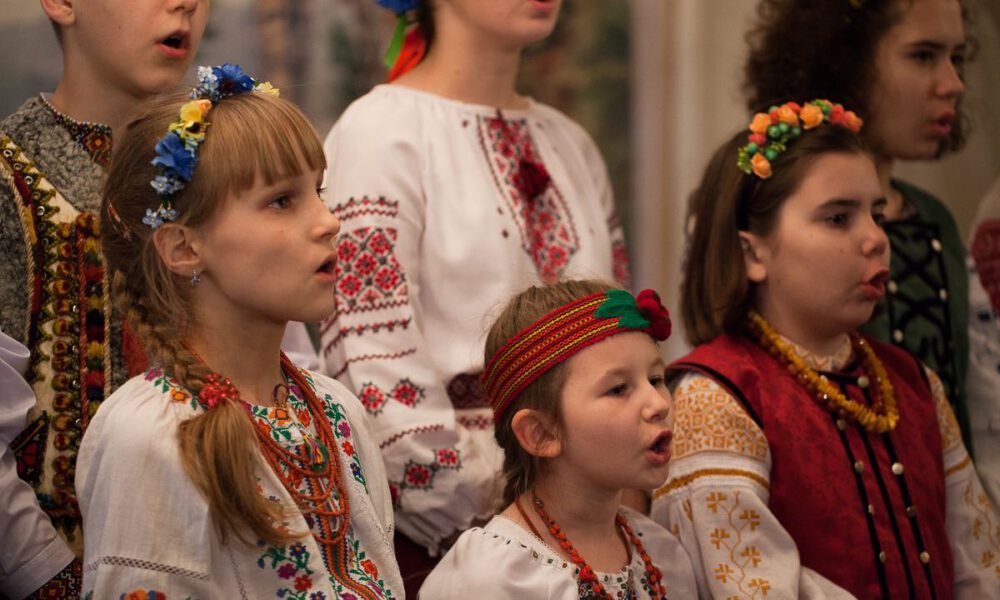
76, 386, 219, 599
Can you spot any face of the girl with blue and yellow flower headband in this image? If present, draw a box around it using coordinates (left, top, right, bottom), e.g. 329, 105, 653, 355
194, 171, 340, 324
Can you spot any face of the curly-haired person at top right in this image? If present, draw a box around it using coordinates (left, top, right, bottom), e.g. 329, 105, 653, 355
862, 0, 965, 160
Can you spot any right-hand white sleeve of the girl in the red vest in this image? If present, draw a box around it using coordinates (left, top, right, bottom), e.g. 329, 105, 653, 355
924, 360, 1000, 600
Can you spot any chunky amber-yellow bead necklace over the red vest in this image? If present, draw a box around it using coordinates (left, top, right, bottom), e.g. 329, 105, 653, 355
749, 311, 899, 433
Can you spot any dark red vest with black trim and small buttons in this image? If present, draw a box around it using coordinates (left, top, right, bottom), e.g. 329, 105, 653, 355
670, 336, 954, 600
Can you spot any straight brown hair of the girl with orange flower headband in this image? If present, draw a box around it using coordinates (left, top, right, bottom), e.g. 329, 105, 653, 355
681, 125, 871, 346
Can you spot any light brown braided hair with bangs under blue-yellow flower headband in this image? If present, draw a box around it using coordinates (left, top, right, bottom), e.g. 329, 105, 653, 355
101, 92, 326, 544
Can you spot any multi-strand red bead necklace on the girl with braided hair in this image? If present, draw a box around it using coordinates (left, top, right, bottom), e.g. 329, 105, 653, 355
199, 353, 350, 557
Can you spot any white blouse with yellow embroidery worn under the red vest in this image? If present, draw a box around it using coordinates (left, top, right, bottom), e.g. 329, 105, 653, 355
651, 337, 1000, 600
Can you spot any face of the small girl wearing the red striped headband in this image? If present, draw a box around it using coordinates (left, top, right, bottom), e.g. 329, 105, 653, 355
552, 331, 673, 492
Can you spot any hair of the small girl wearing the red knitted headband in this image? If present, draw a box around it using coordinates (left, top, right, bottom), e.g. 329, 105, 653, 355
484, 280, 616, 506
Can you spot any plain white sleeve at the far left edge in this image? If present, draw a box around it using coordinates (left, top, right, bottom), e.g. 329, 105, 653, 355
0, 332, 73, 599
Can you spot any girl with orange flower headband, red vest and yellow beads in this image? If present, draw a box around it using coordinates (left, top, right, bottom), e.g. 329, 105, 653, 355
652, 100, 1000, 598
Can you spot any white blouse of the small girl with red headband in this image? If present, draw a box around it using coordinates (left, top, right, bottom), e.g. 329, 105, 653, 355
420, 508, 707, 600
